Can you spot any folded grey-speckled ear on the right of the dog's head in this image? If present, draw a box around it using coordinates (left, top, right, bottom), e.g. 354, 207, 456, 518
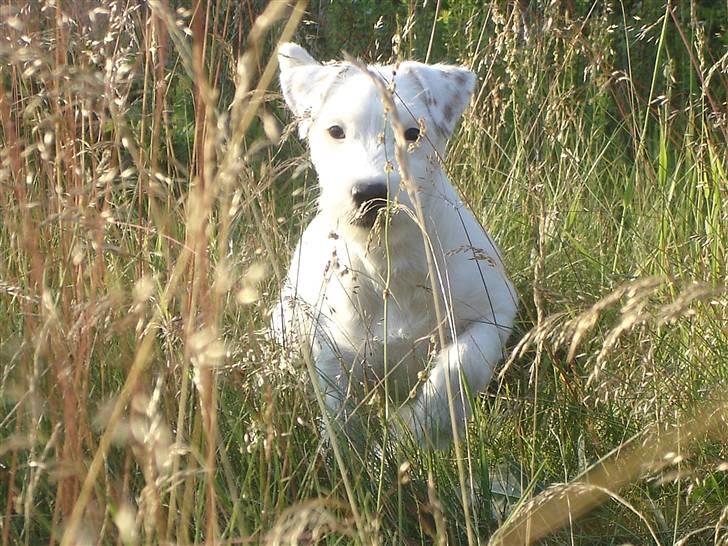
400, 61, 476, 138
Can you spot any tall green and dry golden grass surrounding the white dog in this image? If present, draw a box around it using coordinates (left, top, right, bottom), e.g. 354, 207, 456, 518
0, 0, 728, 546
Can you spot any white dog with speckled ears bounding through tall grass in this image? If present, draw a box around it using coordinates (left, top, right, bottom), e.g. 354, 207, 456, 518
272, 43, 517, 447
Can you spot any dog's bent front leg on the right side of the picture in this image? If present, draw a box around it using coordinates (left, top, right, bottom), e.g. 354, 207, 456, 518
399, 319, 508, 448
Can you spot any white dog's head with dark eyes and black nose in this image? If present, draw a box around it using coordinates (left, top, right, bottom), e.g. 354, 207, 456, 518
278, 43, 475, 228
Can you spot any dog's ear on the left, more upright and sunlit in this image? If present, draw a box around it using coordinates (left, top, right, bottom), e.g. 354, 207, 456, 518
278, 43, 341, 139
